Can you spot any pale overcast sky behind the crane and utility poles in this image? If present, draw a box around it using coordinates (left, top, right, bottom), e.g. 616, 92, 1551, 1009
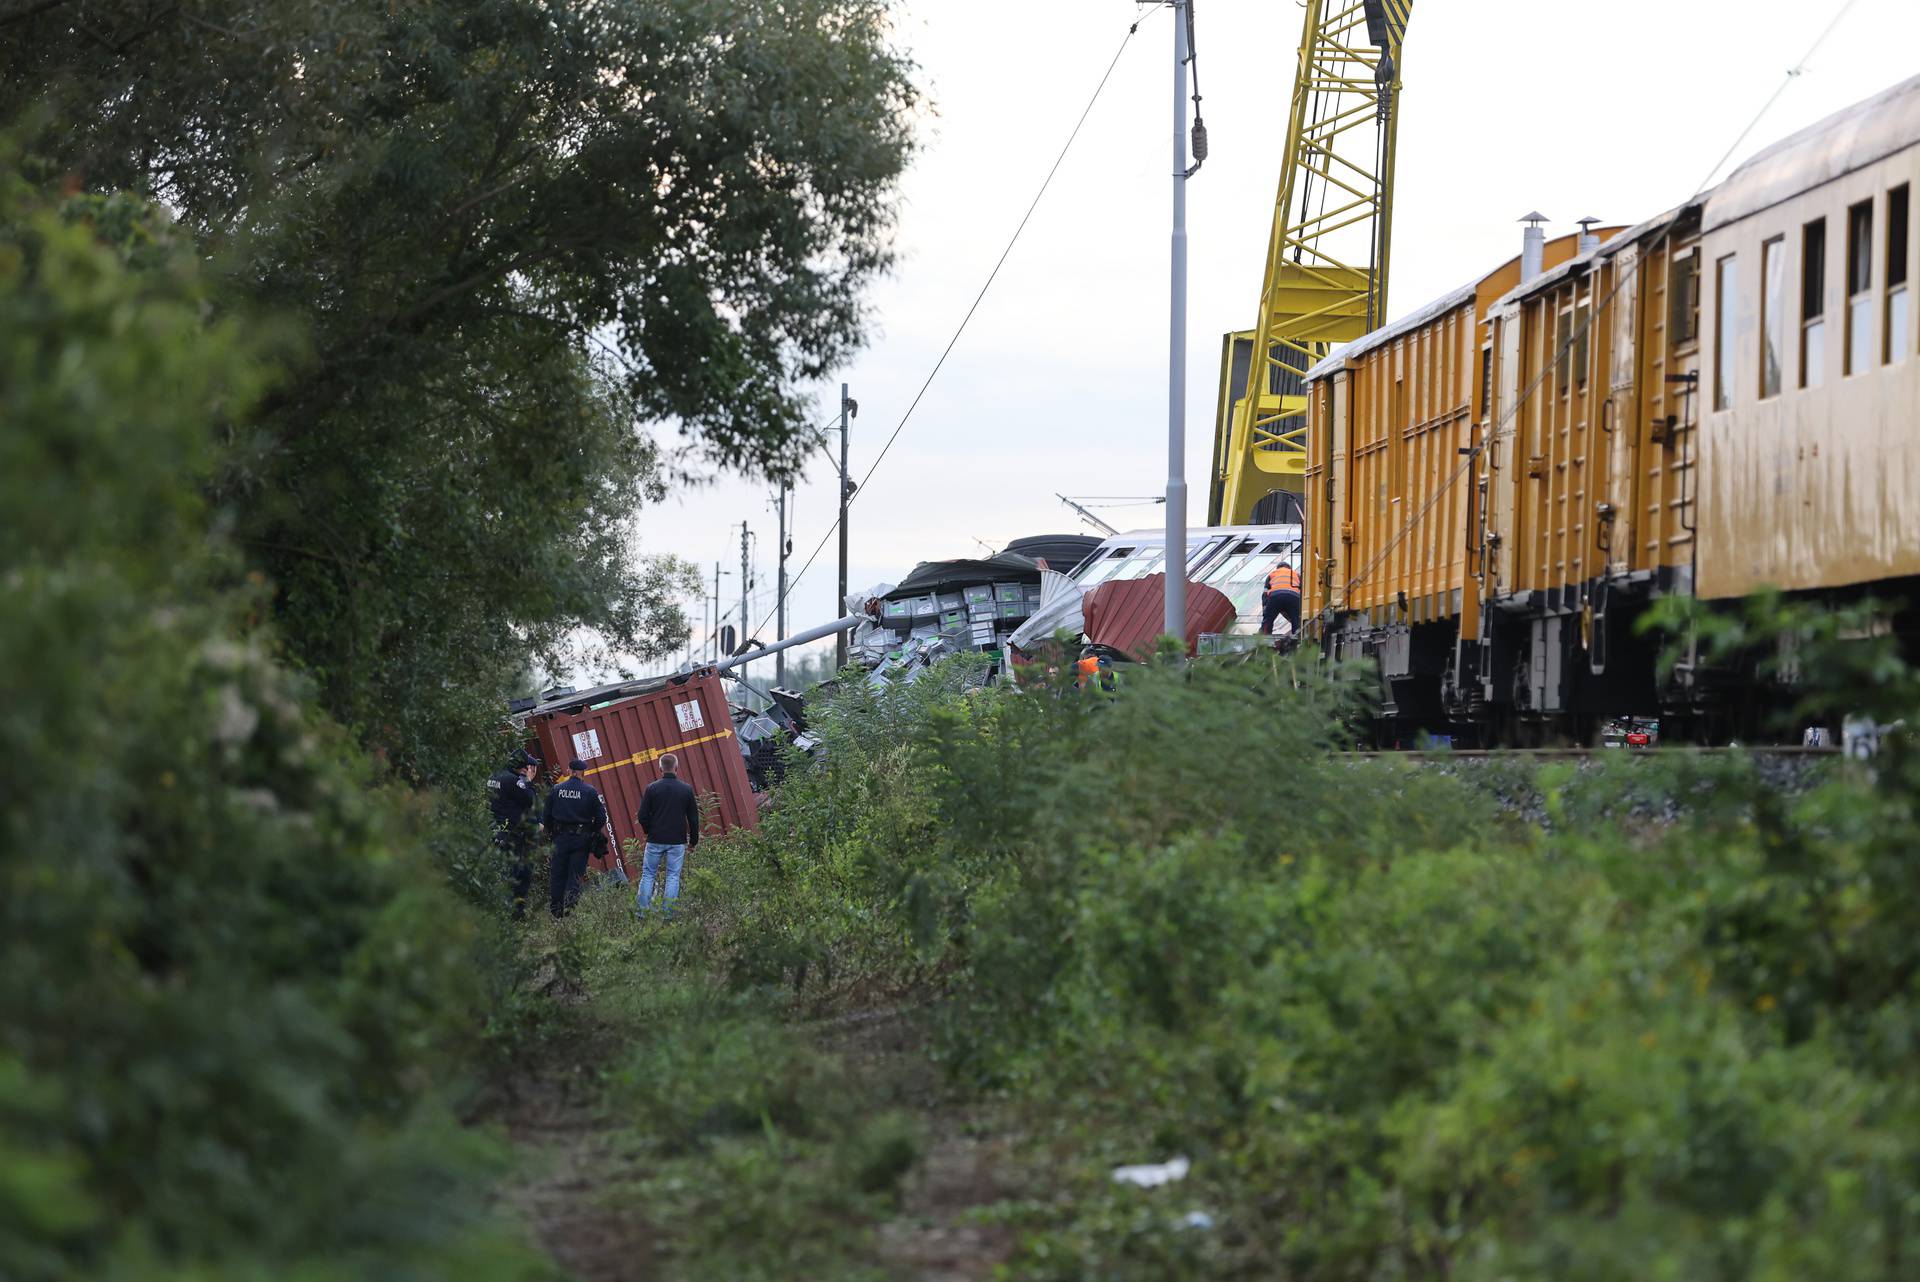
618, 0, 1920, 679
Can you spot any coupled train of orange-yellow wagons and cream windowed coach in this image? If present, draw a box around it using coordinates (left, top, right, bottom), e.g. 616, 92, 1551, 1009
1304, 77, 1920, 743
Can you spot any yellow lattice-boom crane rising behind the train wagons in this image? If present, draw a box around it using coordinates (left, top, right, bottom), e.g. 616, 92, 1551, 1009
1208, 0, 1413, 526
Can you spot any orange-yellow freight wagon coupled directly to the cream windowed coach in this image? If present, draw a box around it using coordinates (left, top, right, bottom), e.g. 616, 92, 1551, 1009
1457, 207, 1699, 737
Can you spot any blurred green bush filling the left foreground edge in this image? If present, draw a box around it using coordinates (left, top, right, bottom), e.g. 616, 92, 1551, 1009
0, 172, 530, 1280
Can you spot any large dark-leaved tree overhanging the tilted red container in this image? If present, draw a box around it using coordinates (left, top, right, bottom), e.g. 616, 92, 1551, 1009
0, 0, 914, 779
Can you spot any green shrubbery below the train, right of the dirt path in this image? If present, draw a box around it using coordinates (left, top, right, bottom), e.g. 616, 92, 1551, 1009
675, 629, 1920, 1280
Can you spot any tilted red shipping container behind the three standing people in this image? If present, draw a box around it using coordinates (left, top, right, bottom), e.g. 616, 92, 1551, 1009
526, 668, 760, 875
